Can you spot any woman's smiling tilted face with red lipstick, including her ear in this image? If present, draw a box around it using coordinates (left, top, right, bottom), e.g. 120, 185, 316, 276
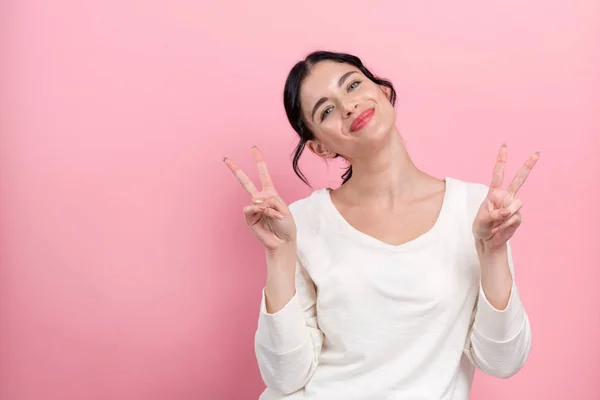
300, 61, 396, 161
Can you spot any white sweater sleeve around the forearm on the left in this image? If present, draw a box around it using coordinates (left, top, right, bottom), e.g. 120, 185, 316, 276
255, 261, 323, 394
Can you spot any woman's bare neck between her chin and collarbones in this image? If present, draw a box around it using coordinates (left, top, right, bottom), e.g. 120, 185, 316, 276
340, 128, 427, 202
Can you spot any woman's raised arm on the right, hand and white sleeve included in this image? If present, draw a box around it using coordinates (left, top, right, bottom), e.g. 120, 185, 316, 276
467, 145, 539, 378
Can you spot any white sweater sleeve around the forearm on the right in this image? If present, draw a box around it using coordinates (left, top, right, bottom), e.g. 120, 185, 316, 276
469, 243, 531, 378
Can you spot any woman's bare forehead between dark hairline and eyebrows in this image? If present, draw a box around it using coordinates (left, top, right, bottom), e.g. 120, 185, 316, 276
300, 61, 362, 110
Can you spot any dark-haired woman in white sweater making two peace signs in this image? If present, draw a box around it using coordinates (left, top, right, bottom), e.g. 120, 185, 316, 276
224, 52, 539, 400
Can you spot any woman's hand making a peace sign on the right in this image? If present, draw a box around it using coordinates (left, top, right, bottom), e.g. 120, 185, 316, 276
473, 145, 540, 251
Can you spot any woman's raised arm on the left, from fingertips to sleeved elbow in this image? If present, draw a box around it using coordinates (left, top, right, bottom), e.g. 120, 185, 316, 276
223, 147, 323, 394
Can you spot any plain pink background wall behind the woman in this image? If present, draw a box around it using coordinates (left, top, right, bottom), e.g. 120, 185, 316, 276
0, 0, 600, 400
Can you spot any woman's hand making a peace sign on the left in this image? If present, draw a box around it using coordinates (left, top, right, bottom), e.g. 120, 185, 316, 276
223, 146, 296, 250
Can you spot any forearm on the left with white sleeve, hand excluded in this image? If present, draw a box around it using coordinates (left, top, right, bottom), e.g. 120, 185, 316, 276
255, 244, 323, 394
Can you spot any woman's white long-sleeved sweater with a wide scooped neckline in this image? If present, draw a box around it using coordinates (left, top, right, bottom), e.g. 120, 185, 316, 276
255, 178, 531, 400
